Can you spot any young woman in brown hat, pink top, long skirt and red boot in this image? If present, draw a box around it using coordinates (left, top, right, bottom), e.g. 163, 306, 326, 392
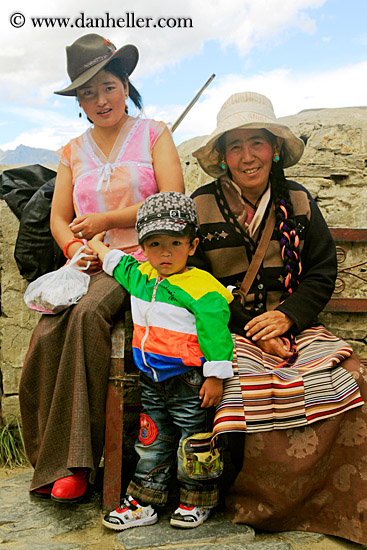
19, 34, 183, 503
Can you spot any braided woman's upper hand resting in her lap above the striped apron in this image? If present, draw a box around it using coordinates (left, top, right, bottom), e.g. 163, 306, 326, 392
245, 309, 293, 343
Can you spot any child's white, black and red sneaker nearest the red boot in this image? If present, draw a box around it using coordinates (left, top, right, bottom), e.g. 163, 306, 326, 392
102, 495, 158, 531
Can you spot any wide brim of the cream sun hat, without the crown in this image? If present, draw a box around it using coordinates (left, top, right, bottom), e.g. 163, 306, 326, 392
192, 116, 305, 178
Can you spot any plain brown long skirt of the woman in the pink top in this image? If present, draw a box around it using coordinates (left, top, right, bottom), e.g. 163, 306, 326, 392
19, 273, 129, 490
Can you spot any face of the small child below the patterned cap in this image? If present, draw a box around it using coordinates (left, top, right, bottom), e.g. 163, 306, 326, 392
141, 235, 199, 279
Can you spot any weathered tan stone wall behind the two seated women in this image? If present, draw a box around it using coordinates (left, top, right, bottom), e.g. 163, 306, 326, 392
0, 107, 367, 421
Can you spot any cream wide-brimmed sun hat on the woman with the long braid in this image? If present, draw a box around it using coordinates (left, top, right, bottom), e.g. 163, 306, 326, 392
192, 92, 304, 178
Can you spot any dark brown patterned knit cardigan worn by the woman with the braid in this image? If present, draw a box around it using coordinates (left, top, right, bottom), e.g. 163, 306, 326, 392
192, 180, 337, 334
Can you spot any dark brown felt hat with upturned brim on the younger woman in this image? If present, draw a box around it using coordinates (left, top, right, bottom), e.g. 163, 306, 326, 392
54, 34, 139, 96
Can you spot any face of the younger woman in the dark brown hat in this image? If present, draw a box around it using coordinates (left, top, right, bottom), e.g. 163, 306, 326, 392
77, 70, 127, 128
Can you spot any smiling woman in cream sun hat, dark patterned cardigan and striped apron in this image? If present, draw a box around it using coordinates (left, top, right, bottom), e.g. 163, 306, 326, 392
193, 92, 367, 543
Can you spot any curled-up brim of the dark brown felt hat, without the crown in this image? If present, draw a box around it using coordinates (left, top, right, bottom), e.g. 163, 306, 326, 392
54, 44, 139, 96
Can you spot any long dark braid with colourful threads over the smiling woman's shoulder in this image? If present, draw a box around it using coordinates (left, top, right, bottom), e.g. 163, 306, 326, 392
270, 162, 302, 301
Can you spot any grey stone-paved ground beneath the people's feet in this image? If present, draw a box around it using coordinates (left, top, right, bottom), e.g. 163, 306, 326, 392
0, 468, 367, 550
